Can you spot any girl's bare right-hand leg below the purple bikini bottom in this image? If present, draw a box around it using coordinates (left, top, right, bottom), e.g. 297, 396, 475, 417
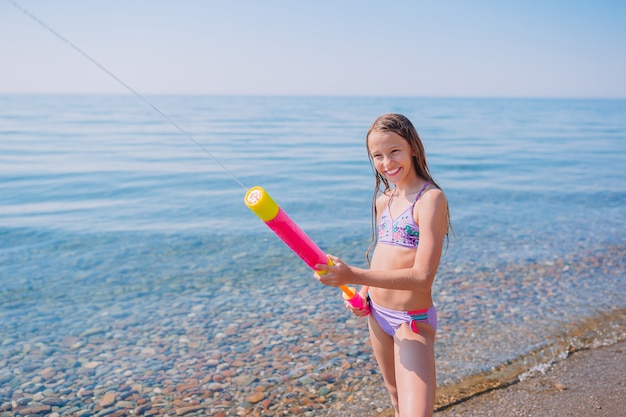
394, 323, 437, 416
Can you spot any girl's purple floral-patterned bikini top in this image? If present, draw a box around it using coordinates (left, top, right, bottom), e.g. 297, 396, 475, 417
378, 182, 430, 249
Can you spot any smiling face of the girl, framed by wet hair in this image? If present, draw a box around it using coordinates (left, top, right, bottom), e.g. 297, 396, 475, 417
367, 130, 417, 186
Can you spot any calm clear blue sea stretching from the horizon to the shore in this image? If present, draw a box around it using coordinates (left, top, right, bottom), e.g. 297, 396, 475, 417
0, 94, 626, 412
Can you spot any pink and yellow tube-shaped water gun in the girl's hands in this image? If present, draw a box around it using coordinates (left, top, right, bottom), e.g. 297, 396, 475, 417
245, 187, 369, 310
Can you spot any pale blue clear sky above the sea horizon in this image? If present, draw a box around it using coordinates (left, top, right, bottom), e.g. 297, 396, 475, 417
0, 0, 626, 99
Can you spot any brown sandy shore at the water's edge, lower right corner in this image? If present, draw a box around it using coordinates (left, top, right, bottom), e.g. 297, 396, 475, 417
428, 341, 626, 417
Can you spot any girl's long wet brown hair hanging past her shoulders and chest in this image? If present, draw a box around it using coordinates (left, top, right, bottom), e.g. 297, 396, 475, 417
365, 113, 452, 265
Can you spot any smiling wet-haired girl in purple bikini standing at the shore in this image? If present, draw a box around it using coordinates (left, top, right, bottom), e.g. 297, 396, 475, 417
315, 114, 450, 417
